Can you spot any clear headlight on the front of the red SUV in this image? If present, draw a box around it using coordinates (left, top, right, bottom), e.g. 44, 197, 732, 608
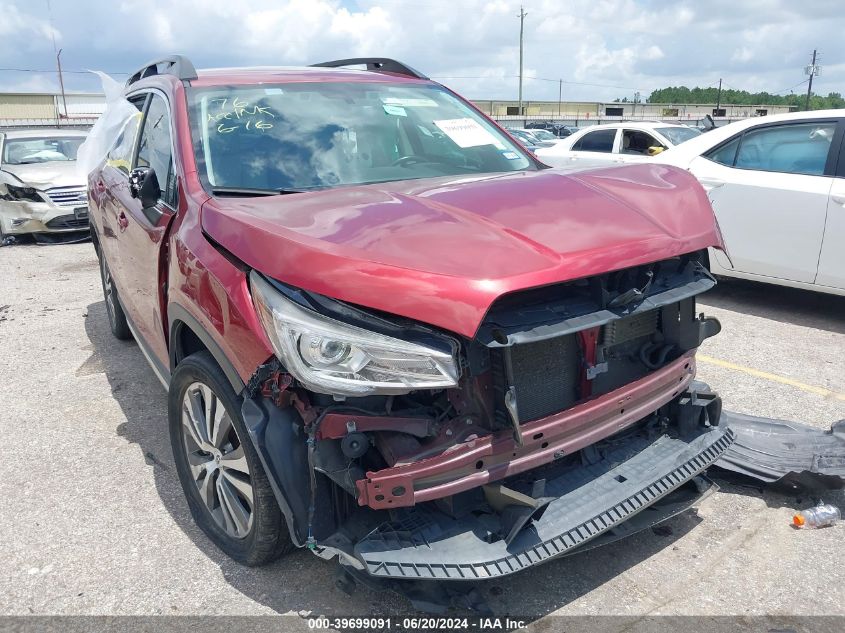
250, 272, 460, 396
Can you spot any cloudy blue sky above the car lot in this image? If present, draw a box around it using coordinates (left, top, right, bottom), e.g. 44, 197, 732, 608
0, 0, 845, 100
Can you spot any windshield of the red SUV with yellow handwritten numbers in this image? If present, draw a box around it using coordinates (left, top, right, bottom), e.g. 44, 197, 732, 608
191, 82, 534, 190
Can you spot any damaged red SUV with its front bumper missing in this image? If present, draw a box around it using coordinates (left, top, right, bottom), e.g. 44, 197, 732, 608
88, 56, 733, 579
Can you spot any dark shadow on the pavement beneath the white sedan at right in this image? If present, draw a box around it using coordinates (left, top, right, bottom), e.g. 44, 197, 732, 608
699, 278, 845, 334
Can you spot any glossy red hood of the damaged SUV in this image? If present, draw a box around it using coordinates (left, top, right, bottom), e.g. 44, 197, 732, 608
201, 165, 720, 336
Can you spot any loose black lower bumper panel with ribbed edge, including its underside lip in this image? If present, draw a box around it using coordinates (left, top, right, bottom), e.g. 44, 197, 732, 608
320, 427, 734, 580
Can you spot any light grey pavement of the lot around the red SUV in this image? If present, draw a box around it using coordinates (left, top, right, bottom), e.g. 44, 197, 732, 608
0, 244, 845, 628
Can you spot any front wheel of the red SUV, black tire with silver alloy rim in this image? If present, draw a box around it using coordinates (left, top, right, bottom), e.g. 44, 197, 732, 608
168, 351, 293, 566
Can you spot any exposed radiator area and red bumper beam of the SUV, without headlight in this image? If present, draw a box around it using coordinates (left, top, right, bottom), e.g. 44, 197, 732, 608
237, 253, 732, 556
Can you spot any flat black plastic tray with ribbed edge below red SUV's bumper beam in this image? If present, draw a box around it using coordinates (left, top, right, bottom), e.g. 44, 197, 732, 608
354, 427, 734, 580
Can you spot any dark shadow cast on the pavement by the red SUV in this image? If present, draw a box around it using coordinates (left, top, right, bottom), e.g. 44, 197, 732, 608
85, 301, 712, 620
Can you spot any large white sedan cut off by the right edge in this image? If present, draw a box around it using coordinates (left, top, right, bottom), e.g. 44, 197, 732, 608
655, 110, 845, 295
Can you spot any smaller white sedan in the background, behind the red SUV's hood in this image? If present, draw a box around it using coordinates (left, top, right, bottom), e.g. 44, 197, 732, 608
536, 121, 701, 168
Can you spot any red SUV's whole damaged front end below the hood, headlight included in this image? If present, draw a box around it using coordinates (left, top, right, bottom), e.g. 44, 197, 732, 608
243, 252, 734, 580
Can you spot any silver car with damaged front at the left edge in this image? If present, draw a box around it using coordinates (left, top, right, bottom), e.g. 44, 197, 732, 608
0, 129, 88, 242
